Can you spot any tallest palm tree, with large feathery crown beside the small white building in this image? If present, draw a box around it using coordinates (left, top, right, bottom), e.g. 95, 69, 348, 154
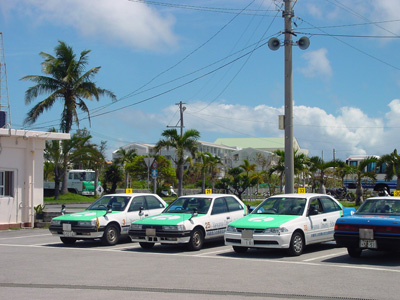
21, 41, 116, 193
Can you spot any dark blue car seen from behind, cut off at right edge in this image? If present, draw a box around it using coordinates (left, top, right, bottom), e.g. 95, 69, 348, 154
334, 196, 400, 257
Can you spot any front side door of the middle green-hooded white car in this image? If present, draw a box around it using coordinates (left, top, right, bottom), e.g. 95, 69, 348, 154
206, 197, 231, 238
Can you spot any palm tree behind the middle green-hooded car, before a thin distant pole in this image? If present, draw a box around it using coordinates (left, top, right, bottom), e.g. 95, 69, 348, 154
155, 129, 200, 196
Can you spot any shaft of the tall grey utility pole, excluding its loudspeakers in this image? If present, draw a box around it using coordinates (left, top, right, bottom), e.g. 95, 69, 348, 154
283, 0, 294, 194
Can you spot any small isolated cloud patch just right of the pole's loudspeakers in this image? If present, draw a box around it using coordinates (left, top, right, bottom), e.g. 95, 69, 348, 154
299, 48, 332, 78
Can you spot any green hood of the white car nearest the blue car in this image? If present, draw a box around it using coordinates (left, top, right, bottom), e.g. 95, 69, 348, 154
229, 214, 301, 229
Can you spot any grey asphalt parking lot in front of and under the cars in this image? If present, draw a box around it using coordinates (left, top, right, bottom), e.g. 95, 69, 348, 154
0, 229, 400, 299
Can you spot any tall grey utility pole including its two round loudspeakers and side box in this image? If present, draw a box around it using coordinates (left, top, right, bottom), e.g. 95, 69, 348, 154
268, 0, 310, 194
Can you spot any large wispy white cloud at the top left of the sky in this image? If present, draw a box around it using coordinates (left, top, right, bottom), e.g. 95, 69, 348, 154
10, 0, 178, 51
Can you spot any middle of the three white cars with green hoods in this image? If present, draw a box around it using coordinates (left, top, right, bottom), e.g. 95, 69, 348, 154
129, 194, 247, 250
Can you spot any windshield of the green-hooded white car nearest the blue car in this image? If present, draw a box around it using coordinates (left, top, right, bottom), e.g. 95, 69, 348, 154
252, 197, 307, 216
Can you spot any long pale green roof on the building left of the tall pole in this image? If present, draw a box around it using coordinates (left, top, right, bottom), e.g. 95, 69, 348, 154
214, 137, 285, 149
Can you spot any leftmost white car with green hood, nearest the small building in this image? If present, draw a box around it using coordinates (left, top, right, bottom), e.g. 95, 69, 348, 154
49, 193, 167, 245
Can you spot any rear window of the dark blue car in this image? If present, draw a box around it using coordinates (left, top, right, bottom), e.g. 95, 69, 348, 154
356, 199, 400, 215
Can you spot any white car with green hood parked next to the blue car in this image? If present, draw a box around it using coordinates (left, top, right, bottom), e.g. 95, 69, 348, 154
224, 193, 355, 255
